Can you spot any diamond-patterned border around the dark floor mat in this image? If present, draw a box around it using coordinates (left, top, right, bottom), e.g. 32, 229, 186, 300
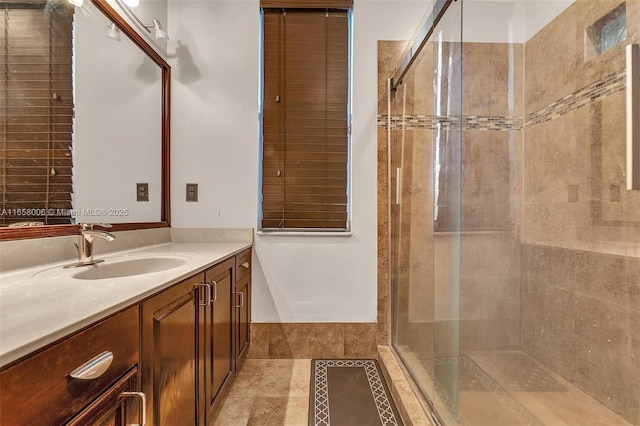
309, 359, 402, 426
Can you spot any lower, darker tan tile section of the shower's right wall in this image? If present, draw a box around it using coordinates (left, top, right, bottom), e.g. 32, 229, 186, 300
522, 245, 640, 424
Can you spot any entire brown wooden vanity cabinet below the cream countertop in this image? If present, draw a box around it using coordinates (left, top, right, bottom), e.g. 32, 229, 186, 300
0, 249, 251, 426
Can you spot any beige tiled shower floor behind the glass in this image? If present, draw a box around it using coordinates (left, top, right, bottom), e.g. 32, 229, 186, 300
401, 351, 631, 426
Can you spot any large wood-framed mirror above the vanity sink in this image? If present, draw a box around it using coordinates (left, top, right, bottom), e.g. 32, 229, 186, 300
0, 0, 170, 239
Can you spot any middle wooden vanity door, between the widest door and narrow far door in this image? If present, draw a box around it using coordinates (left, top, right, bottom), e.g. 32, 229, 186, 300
202, 259, 235, 418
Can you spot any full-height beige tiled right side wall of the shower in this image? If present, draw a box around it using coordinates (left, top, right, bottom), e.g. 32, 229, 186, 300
520, 0, 640, 424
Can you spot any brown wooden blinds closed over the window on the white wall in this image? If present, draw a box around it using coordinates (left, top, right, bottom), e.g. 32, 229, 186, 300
262, 9, 349, 231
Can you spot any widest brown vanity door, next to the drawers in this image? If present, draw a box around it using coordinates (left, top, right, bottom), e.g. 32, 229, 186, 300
142, 275, 203, 426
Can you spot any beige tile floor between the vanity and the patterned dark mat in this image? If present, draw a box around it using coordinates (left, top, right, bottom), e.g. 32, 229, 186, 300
213, 359, 311, 426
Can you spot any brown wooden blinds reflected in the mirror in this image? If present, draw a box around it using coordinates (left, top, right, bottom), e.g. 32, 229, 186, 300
0, 0, 73, 225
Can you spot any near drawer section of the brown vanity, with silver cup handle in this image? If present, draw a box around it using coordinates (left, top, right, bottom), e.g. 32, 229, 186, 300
0, 305, 141, 426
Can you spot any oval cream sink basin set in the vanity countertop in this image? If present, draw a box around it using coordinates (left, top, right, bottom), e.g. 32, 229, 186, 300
72, 257, 186, 280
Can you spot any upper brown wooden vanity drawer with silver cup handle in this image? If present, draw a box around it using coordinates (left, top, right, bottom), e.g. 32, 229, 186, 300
0, 305, 140, 425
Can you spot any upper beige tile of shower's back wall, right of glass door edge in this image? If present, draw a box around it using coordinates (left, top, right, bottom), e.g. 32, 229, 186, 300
461, 43, 524, 231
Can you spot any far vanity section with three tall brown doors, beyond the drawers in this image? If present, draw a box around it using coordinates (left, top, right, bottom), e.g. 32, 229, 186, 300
141, 249, 251, 426
